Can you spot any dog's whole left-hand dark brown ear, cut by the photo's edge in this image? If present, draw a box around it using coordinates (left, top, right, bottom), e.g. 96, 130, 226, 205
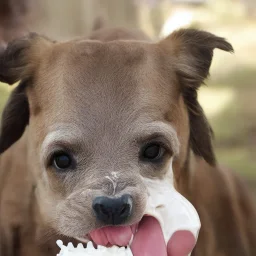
0, 33, 50, 153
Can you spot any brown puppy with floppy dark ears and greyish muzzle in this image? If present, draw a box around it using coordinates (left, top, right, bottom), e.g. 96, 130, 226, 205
0, 24, 256, 256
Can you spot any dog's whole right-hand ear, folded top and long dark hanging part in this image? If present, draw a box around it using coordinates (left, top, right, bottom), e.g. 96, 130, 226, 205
160, 29, 233, 165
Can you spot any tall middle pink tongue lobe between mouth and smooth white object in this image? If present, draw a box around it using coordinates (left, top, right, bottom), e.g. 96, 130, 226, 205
131, 217, 167, 256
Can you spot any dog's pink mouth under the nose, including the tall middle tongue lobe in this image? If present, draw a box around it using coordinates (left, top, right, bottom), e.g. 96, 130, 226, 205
75, 216, 167, 256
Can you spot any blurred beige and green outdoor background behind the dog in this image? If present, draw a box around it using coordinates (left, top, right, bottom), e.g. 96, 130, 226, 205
0, 0, 256, 191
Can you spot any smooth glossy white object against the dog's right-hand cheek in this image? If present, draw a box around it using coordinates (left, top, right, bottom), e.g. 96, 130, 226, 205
145, 175, 201, 244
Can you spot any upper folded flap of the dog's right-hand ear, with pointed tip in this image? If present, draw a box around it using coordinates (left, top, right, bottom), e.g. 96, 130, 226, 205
160, 29, 233, 89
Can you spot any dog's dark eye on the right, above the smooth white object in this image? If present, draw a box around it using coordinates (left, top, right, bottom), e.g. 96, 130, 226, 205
141, 143, 165, 161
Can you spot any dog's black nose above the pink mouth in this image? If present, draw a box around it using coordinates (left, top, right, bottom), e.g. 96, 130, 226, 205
92, 195, 132, 225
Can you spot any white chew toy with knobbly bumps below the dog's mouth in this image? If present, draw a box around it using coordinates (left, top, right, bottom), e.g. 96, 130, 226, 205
57, 240, 132, 256
